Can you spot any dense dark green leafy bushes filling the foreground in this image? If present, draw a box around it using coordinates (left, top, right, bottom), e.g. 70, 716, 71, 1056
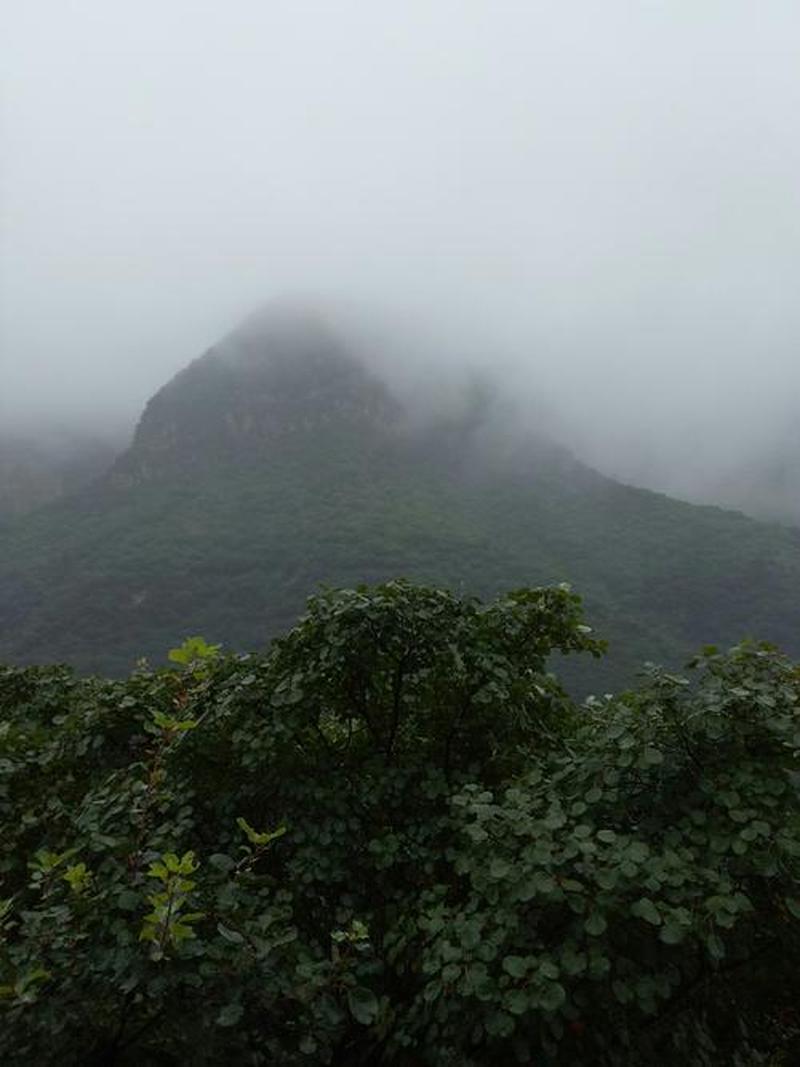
0, 582, 800, 1067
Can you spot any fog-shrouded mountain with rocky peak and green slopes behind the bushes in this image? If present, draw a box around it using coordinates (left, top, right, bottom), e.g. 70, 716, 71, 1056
0, 312, 800, 688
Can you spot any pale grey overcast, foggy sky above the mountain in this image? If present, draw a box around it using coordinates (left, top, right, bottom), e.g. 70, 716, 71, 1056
0, 0, 800, 499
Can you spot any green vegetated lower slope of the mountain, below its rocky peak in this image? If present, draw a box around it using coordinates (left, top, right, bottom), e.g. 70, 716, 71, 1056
0, 403, 800, 691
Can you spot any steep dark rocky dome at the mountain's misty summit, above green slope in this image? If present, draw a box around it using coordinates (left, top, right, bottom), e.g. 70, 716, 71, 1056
113, 309, 400, 481
